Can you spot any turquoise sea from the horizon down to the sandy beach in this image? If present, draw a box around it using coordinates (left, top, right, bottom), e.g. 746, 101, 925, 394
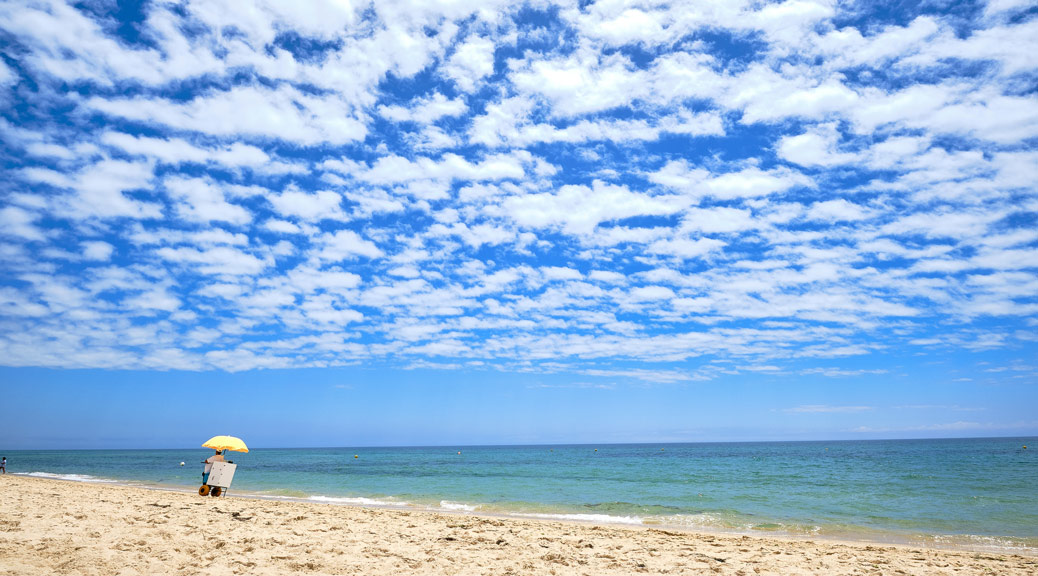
5, 438, 1038, 553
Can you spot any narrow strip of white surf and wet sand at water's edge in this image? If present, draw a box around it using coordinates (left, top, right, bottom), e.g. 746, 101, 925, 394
9, 472, 1038, 557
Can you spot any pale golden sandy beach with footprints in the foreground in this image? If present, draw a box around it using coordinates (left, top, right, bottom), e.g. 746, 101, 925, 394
0, 474, 1038, 576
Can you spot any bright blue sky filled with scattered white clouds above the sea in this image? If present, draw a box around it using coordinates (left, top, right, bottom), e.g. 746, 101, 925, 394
0, 0, 1038, 448
